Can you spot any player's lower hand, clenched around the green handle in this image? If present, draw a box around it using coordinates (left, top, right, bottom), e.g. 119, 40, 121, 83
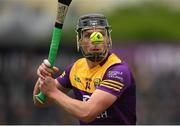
39, 77, 58, 98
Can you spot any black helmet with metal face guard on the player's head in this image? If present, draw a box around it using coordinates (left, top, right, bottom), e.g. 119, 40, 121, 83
76, 14, 112, 62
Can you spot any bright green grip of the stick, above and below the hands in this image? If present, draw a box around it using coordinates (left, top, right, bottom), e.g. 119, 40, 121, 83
36, 27, 62, 104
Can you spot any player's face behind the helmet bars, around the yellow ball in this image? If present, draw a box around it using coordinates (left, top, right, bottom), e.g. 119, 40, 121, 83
80, 28, 109, 53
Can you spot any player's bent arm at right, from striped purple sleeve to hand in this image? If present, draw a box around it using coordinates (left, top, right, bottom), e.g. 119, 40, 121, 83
41, 65, 130, 122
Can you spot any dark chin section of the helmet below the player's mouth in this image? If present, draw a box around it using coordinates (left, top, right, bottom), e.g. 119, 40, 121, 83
80, 47, 108, 62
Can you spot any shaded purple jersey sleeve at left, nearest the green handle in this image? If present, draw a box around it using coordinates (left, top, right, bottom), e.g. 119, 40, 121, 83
56, 64, 73, 89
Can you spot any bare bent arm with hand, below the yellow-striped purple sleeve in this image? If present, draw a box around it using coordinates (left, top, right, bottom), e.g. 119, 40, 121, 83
41, 77, 117, 122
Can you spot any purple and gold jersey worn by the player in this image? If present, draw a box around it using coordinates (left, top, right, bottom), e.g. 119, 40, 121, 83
57, 53, 136, 125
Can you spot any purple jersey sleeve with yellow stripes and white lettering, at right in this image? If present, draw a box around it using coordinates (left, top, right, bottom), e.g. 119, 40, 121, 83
97, 64, 132, 97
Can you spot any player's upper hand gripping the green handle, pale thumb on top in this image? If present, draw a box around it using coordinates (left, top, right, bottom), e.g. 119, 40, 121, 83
37, 59, 59, 80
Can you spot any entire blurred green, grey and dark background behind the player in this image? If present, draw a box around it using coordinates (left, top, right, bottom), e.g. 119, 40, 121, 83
0, 0, 180, 125
